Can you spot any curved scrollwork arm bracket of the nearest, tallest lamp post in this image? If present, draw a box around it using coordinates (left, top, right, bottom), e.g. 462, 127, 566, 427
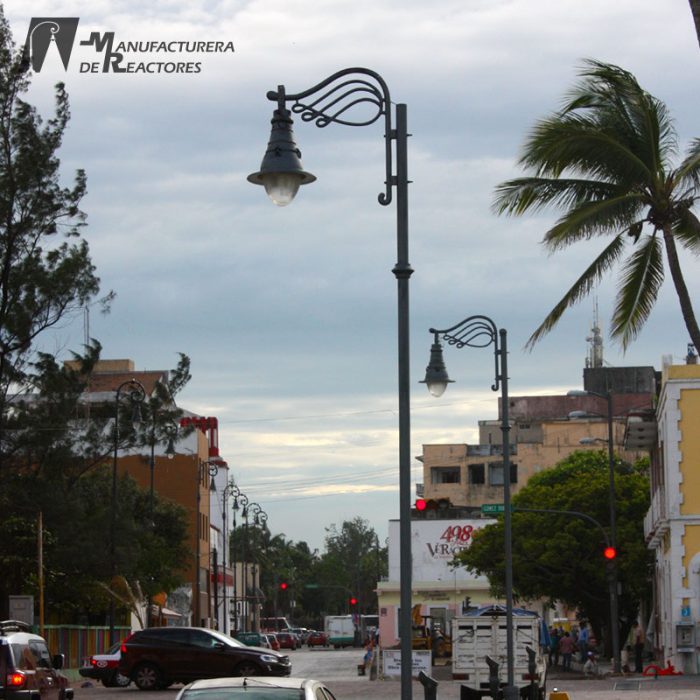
267, 68, 397, 206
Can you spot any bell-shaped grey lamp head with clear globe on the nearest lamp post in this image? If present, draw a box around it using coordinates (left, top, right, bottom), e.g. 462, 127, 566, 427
248, 107, 316, 207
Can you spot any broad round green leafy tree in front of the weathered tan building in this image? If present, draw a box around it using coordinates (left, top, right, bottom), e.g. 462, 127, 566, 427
456, 451, 651, 639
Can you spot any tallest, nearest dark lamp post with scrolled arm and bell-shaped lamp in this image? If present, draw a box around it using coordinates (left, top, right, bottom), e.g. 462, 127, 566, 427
248, 68, 413, 700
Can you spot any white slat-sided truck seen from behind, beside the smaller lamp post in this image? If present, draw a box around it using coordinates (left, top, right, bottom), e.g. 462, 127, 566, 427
452, 605, 547, 700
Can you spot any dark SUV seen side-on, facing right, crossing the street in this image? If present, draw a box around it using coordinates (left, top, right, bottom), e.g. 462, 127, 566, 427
119, 627, 292, 690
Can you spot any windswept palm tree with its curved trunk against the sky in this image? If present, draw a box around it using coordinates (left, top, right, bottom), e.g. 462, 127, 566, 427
493, 60, 700, 349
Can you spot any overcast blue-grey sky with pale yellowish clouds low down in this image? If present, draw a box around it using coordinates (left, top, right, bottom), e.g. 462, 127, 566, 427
4, 0, 700, 548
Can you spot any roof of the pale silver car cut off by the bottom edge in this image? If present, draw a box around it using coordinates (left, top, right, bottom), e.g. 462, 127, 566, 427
175, 678, 335, 700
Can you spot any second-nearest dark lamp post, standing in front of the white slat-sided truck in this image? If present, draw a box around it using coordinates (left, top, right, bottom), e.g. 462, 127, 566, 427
422, 316, 518, 700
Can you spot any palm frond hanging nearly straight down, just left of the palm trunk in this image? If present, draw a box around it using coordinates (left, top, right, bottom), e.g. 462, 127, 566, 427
610, 234, 664, 350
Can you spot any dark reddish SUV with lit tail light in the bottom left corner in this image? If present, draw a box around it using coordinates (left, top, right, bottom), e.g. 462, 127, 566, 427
0, 620, 73, 700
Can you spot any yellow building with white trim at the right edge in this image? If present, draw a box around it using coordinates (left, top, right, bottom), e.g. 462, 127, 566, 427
640, 352, 700, 674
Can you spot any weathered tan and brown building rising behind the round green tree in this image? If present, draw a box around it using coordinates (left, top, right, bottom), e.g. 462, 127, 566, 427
418, 367, 656, 514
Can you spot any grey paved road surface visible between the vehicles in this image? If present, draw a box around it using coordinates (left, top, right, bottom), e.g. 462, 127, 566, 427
69, 648, 700, 700
